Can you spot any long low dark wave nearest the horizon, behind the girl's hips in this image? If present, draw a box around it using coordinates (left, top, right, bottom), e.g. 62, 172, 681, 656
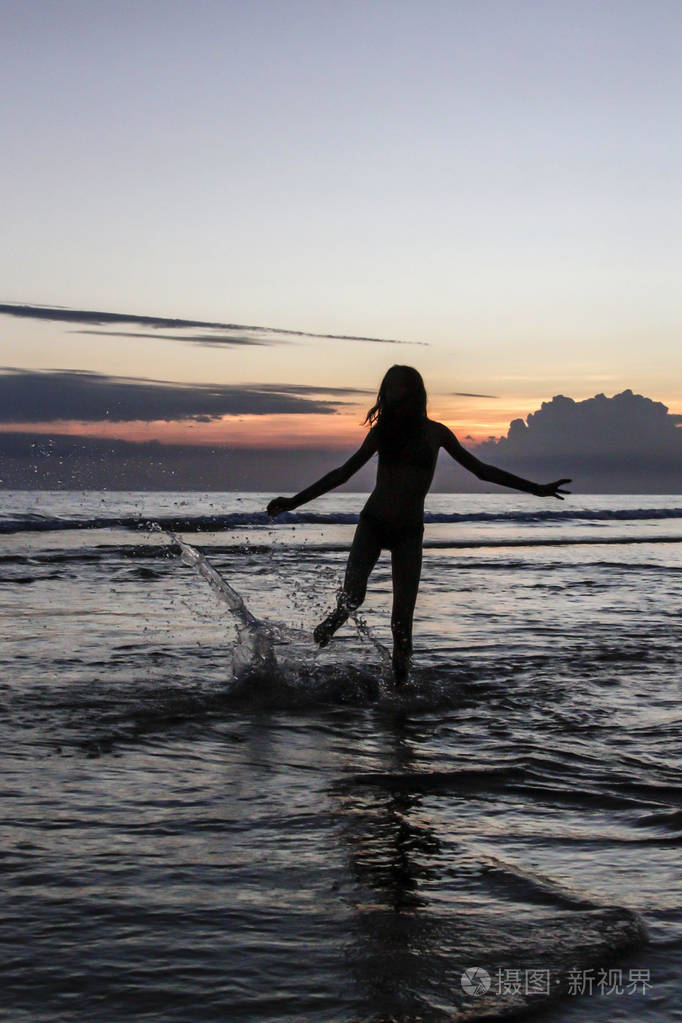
0, 503, 682, 534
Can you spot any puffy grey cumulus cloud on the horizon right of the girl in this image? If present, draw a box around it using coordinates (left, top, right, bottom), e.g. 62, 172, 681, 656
476, 390, 682, 493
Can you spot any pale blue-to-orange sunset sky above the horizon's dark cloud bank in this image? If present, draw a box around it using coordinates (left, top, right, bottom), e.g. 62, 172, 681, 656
0, 0, 682, 482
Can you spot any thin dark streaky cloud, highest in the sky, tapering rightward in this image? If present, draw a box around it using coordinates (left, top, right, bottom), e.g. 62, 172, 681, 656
0, 303, 426, 346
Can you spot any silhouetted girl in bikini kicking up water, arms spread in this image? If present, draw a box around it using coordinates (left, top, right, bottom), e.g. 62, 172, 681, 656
267, 365, 571, 684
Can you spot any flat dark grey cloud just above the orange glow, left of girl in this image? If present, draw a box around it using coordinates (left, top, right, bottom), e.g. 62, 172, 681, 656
0, 369, 352, 424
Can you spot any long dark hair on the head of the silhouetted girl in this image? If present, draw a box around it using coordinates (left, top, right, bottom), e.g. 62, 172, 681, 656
364, 365, 426, 455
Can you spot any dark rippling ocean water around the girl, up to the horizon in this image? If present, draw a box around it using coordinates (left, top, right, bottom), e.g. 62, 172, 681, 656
0, 491, 682, 1023
